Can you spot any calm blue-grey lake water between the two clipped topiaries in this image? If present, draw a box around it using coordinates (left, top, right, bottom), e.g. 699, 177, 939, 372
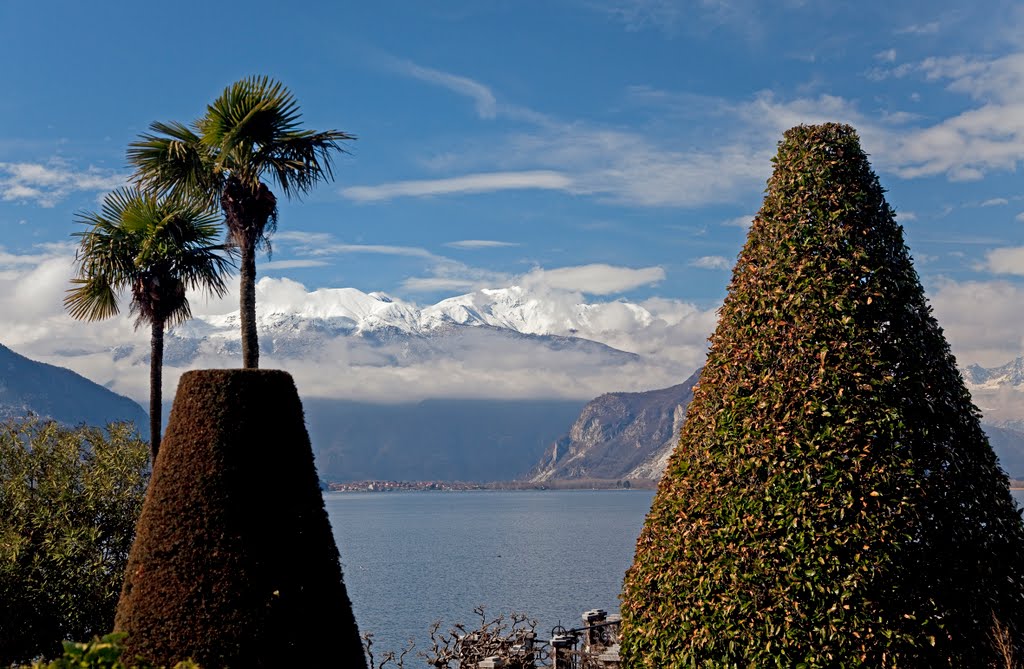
324, 491, 1024, 655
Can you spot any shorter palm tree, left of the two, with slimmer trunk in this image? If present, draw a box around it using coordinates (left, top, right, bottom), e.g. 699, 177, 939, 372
65, 189, 231, 462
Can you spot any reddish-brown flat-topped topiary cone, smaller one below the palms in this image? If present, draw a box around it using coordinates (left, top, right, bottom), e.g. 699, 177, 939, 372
115, 370, 366, 668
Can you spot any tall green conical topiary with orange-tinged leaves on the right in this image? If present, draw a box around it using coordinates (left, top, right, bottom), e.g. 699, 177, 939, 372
622, 124, 1024, 669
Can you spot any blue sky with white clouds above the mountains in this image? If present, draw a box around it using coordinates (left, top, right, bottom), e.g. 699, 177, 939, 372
0, 0, 1024, 397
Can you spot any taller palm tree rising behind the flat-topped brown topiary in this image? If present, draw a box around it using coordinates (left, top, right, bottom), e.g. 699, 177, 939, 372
128, 77, 355, 368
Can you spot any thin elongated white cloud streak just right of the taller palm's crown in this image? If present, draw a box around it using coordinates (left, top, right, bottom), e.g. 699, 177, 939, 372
341, 170, 572, 202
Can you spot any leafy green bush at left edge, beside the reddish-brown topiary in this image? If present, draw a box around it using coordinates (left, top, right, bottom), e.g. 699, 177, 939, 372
0, 418, 148, 665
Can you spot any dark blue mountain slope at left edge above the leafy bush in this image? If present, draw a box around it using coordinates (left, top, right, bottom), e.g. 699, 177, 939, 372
0, 345, 148, 431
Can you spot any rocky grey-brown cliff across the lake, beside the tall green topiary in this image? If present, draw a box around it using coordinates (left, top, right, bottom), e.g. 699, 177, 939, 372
527, 370, 700, 483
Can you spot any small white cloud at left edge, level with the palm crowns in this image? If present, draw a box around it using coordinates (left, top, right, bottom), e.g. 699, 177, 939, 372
0, 160, 128, 207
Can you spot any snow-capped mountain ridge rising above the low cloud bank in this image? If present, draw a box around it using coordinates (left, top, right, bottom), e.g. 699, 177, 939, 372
148, 280, 671, 367
